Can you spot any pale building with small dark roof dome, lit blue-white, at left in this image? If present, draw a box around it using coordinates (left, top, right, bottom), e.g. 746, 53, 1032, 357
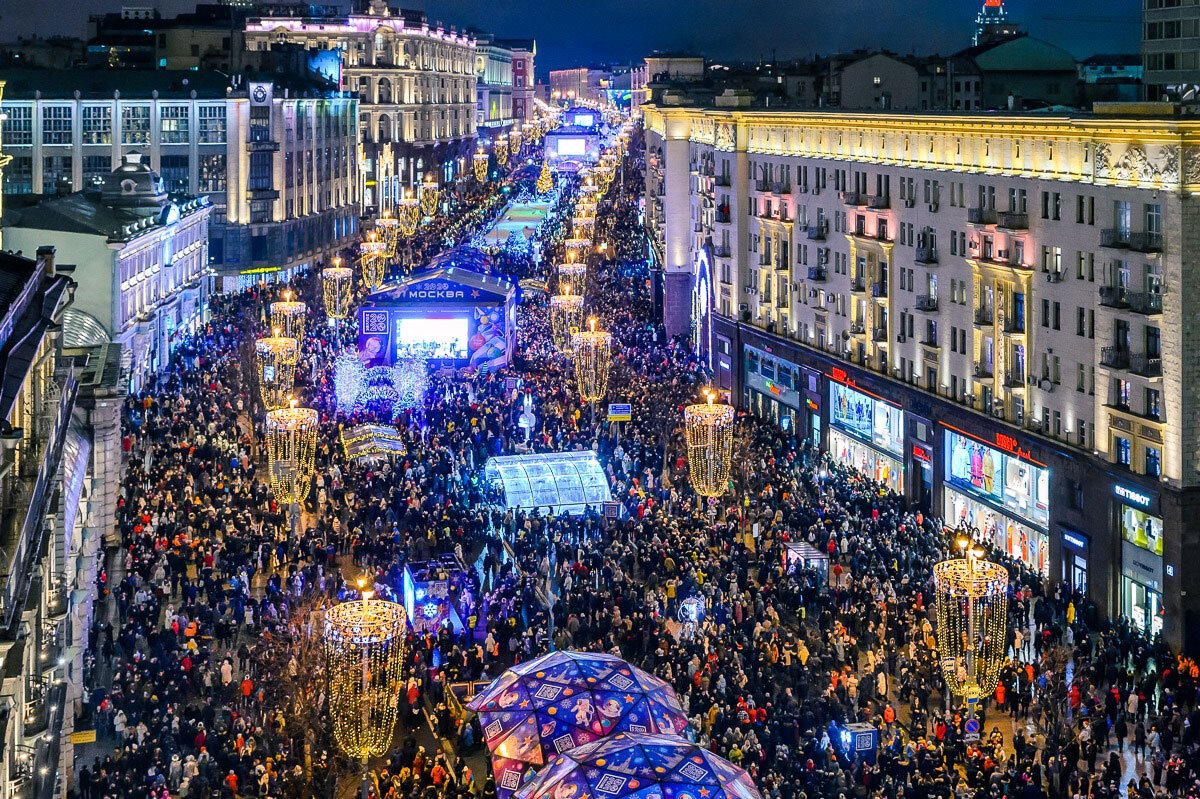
4, 152, 211, 391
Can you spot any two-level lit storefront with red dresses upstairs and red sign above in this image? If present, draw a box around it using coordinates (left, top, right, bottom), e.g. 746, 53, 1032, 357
942, 423, 1050, 576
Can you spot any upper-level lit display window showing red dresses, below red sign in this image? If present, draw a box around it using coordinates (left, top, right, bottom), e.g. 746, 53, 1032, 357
946, 429, 1050, 527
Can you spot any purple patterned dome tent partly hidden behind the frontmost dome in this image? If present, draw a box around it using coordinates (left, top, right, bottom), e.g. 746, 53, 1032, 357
468, 651, 701, 799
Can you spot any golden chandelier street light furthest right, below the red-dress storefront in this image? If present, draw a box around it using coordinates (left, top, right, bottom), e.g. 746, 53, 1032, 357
934, 535, 1008, 703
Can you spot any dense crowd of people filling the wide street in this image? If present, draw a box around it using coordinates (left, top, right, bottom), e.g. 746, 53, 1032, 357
73, 118, 1200, 799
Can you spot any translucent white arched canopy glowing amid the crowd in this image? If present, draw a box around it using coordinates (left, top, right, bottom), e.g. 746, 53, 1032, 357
485, 450, 612, 513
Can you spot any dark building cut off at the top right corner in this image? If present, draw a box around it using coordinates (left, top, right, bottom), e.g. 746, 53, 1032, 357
1141, 0, 1200, 100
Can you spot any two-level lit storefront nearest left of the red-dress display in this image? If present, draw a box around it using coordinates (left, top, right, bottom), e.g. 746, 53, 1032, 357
829, 379, 905, 494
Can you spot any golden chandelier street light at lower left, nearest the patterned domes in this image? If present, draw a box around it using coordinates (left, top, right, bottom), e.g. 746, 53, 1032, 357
325, 579, 408, 791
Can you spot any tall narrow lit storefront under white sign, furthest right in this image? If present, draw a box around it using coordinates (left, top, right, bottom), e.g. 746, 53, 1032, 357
1112, 483, 1163, 635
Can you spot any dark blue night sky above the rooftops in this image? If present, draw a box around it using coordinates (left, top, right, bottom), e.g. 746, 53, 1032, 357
0, 0, 1140, 78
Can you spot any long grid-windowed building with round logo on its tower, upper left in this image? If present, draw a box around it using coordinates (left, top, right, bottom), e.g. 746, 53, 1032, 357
0, 70, 361, 290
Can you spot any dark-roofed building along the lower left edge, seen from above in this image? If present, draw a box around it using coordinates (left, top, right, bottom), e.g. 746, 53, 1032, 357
0, 77, 121, 799
